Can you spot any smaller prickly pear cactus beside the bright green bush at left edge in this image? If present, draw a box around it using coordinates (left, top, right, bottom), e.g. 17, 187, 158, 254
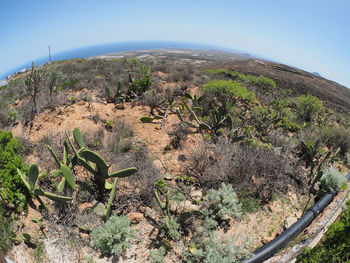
17, 164, 73, 210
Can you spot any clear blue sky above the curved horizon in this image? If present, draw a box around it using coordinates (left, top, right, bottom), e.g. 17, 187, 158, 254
0, 0, 350, 88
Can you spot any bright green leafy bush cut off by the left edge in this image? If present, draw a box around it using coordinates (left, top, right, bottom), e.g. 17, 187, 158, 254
0, 131, 27, 212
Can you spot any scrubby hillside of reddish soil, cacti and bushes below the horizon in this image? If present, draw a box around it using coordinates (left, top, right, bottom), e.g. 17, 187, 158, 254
0, 50, 350, 263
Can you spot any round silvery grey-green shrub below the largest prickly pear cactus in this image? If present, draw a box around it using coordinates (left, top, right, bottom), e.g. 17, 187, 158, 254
92, 215, 134, 255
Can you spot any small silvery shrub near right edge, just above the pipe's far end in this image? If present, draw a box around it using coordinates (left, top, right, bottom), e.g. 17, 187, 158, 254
320, 167, 346, 191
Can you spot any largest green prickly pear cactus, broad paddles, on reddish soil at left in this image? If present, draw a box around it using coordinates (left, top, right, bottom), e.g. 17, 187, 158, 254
66, 127, 137, 199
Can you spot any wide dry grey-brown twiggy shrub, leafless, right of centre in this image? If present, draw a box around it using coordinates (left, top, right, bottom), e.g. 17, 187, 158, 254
190, 139, 300, 202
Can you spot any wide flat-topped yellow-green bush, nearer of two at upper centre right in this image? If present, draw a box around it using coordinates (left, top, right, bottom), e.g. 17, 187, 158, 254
203, 79, 256, 102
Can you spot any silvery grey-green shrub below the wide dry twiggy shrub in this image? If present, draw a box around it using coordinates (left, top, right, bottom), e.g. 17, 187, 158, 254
202, 183, 242, 230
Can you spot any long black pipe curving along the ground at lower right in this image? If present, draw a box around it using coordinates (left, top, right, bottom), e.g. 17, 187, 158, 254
243, 173, 350, 263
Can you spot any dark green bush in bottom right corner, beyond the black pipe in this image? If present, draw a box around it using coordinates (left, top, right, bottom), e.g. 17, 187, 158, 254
298, 201, 350, 263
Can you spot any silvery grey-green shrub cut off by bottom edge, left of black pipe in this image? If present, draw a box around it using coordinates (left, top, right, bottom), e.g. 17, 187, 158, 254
184, 233, 249, 263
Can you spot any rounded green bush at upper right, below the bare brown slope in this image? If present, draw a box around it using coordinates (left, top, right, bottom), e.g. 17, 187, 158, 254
294, 95, 325, 122
